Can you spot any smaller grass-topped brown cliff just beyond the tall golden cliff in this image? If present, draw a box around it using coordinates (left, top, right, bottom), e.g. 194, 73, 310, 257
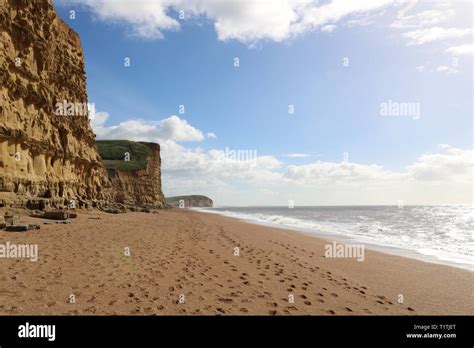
97, 140, 165, 207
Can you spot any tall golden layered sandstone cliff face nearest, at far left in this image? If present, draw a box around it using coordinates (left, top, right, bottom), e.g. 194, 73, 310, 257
0, 0, 110, 207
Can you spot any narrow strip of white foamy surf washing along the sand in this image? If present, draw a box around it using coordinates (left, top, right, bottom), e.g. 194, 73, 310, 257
191, 207, 474, 272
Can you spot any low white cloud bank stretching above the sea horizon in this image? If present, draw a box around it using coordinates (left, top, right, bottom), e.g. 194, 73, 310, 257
91, 112, 474, 205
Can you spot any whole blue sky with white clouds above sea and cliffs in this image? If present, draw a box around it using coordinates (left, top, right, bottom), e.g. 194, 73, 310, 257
53, 0, 474, 206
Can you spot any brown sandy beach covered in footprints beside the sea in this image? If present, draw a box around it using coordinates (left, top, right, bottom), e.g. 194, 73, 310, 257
0, 209, 474, 315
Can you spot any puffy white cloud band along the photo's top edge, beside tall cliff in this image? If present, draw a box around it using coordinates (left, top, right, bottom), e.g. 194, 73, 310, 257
62, 0, 396, 45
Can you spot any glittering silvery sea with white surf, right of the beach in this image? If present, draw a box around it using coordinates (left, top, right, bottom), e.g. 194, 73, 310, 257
194, 205, 474, 271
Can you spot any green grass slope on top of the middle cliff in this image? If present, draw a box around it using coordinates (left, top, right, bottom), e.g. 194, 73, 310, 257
97, 140, 151, 176
